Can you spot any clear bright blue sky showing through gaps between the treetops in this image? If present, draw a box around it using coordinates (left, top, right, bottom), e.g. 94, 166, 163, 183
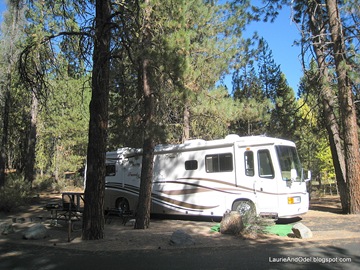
0, 0, 303, 93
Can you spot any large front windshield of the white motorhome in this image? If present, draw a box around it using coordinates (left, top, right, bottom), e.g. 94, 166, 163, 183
276, 145, 302, 182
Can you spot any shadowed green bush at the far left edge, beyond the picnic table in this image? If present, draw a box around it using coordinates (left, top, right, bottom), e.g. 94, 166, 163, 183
0, 176, 31, 212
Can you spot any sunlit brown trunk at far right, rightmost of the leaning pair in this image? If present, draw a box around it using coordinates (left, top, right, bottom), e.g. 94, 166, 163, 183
326, 0, 360, 214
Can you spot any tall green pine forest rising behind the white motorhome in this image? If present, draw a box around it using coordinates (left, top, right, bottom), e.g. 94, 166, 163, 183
0, 0, 360, 238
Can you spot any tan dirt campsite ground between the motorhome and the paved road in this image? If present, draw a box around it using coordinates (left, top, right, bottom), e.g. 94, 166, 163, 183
0, 194, 360, 251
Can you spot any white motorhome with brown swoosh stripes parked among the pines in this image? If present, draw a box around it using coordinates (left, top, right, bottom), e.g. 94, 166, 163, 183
105, 135, 310, 218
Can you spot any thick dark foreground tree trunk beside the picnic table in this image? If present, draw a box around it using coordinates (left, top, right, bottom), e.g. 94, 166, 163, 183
82, 0, 111, 240
